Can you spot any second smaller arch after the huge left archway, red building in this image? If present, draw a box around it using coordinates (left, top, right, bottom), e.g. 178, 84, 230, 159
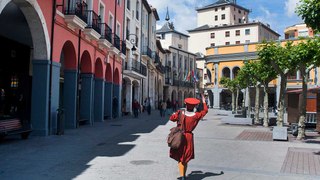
79, 51, 94, 125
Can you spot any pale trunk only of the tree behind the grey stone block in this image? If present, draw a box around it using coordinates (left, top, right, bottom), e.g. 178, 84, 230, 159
277, 75, 287, 127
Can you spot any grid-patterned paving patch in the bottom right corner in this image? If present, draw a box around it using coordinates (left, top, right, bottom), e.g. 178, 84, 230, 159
281, 147, 320, 175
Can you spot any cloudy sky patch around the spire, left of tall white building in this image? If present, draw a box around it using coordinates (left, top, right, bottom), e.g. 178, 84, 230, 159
148, 0, 211, 33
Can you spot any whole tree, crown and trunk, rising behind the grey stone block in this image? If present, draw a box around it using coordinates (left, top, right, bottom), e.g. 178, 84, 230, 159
258, 41, 295, 126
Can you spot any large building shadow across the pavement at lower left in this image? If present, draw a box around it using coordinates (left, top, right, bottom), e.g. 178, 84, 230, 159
0, 111, 169, 179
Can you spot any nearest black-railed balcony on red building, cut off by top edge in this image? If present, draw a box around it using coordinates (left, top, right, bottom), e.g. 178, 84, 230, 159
64, 0, 88, 30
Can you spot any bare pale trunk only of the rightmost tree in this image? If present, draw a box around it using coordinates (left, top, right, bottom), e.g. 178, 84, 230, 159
297, 68, 308, 140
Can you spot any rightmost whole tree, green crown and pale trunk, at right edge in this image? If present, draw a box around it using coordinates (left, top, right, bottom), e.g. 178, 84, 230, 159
290, 38, 320, 140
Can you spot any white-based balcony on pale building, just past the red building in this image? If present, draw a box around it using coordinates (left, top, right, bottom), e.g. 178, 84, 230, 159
123, 60, 147, 79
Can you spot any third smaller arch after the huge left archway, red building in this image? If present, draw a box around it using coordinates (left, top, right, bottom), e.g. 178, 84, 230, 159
94, 58, 105, 122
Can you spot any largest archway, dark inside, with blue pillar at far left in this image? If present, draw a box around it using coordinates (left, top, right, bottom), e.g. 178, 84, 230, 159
0, 1, 51, 135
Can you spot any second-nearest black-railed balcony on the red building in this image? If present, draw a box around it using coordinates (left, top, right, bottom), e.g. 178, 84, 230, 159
84, 10, 101, 40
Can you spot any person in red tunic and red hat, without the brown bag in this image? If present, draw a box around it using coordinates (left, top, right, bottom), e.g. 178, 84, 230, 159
170, 95, 208, 179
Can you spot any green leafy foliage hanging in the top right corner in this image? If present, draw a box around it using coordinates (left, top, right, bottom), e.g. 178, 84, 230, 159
296, 0, 320, 32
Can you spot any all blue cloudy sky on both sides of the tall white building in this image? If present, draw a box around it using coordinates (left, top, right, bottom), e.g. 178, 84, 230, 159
148, 0, 303, 39
